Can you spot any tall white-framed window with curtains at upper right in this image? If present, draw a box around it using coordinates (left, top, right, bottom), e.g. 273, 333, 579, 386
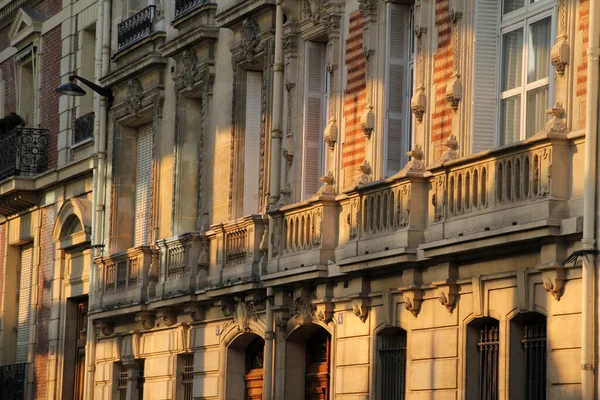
499, 0, 554, 145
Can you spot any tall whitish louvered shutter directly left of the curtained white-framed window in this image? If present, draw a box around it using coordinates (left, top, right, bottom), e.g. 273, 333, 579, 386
471, 0, 500, 153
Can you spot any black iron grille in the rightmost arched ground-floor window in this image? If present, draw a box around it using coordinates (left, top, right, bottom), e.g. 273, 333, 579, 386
521, 321, 546, 400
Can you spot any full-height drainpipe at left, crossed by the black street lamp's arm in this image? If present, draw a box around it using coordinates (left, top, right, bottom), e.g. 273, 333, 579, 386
84, 0, 111, 399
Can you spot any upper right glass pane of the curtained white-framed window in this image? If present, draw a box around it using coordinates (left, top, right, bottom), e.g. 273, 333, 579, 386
527, 17, 552, 83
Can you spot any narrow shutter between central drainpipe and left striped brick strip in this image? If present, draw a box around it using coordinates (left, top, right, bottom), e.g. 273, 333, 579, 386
302, 42, 325, 199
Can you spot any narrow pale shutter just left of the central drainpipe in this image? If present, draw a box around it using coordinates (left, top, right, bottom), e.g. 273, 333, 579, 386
243, 71, 262, 215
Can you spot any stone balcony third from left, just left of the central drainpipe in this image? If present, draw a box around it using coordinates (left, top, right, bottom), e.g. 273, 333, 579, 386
207, 215, 268, 291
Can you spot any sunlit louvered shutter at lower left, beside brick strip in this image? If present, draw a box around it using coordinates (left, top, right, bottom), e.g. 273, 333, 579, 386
16, 244, 33, 363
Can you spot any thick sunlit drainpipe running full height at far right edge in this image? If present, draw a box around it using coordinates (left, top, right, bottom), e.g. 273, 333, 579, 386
581, 1, 600, 399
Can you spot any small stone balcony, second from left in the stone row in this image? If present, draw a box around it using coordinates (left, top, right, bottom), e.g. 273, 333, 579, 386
156, 232, 209, 299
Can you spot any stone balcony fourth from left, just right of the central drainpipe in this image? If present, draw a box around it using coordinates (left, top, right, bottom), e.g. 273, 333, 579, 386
268, 196, 340, 274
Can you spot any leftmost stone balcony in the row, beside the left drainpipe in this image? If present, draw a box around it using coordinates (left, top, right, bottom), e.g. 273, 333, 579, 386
95, 246, 158, 310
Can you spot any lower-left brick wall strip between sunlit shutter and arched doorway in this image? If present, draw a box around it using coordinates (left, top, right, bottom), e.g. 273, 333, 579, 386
33, 207, 56, 399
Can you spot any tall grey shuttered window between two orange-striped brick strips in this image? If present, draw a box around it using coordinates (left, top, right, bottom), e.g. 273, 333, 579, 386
385, 2, 416, 176
